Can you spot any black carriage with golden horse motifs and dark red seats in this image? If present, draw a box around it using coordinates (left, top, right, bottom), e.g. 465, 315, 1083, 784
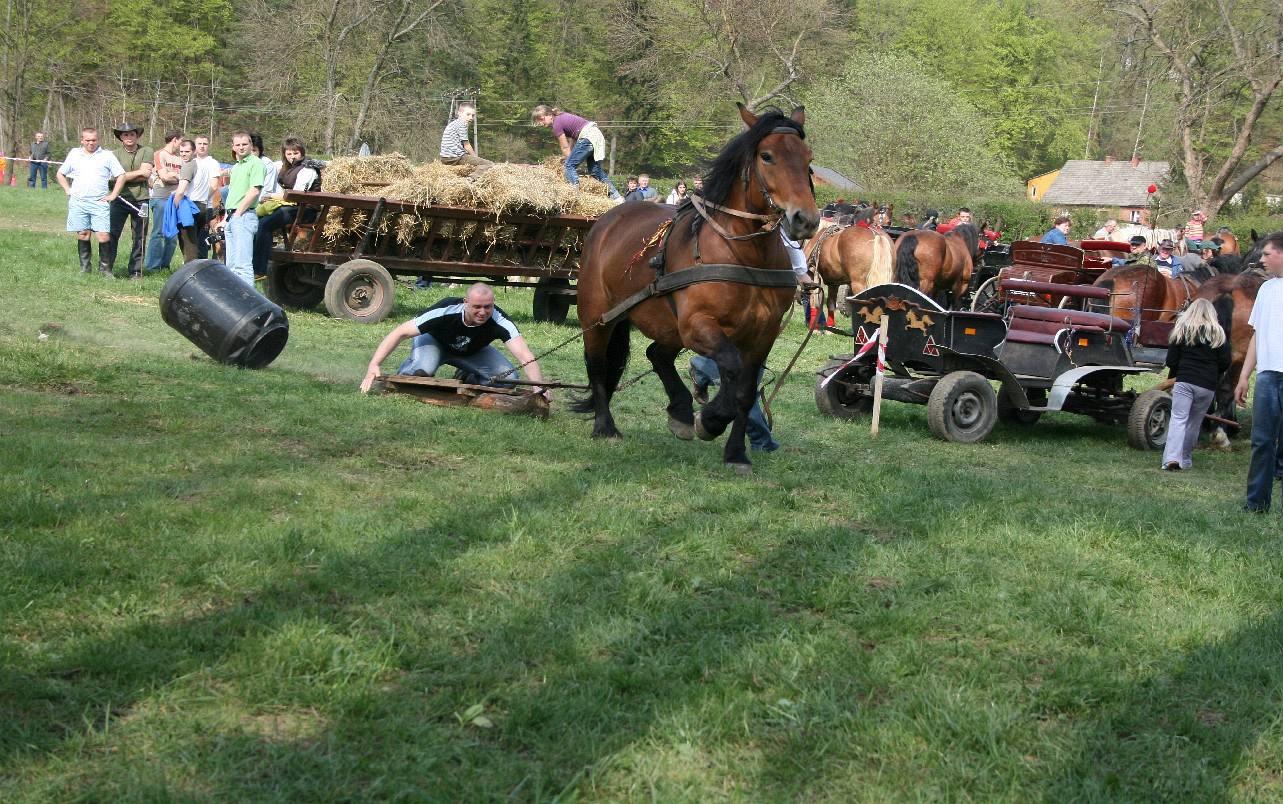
815, 278, 1171, 449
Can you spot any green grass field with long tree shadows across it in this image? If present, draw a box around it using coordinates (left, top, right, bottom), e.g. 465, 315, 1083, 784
0, 188, 1283, 801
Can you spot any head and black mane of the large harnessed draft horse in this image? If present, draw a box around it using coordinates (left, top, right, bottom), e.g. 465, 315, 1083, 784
706, 104, 820, 240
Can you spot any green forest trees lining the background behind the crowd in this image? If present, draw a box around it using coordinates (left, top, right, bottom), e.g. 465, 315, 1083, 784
0, 0, 1283, 214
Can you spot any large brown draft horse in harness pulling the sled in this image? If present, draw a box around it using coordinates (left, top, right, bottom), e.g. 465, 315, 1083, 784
574, 105, 820, 473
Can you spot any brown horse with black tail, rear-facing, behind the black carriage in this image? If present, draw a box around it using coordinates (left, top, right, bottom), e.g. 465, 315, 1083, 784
896, 223, 980, 308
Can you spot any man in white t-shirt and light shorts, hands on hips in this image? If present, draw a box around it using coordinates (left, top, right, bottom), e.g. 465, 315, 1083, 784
56, 128, 124, 277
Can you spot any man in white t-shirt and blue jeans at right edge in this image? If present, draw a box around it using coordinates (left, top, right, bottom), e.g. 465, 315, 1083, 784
1234, 232, 1283, 513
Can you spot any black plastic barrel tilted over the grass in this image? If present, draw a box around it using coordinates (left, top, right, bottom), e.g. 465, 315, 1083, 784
160, 259, 290, 368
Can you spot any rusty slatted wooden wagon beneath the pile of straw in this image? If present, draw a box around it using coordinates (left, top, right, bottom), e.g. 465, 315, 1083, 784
266, 190, 595, 323
